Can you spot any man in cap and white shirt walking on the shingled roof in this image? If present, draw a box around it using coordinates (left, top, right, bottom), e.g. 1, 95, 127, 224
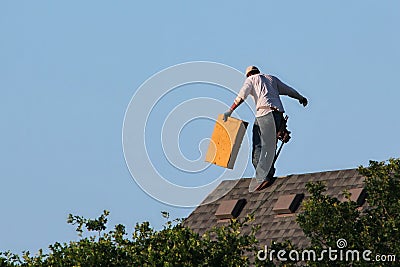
224, 66, 308, 190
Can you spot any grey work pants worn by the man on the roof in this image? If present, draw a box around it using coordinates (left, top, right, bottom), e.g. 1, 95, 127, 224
252, 111, 283, 182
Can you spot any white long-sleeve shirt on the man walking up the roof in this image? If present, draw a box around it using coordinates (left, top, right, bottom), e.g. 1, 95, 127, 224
235, 74, 303, 117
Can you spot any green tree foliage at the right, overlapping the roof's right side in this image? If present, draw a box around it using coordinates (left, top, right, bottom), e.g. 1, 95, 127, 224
297, 159, 400, 266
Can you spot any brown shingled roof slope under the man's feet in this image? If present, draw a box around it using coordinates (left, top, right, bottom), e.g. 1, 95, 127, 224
184, 169, 365, 248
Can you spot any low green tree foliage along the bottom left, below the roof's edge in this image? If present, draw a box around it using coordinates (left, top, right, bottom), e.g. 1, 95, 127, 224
0, 211, 257, 266
